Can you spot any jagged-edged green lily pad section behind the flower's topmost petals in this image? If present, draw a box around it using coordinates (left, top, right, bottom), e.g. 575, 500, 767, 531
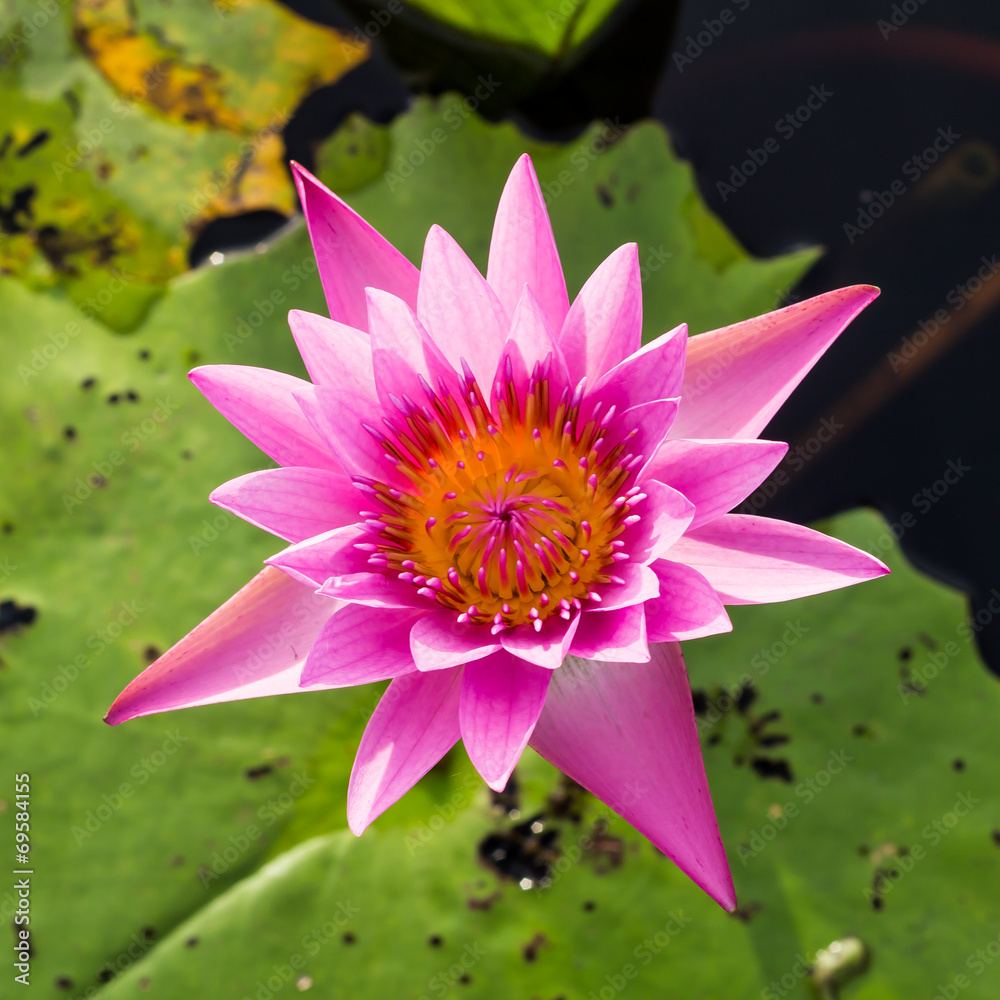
320, 95, 818, 339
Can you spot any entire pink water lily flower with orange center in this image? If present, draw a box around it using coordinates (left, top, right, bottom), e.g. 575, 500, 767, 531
107, 156, 887, 909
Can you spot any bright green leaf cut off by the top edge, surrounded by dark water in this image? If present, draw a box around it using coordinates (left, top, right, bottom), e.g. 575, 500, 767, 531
396, 0, 621, 59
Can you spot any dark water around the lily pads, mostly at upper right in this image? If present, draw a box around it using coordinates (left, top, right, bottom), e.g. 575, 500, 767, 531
195, 0, 1000, 673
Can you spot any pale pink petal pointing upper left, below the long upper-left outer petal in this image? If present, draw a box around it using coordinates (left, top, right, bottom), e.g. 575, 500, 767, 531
288, 309, 377, 400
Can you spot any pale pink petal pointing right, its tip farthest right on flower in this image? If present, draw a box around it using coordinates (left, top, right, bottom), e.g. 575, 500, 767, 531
670, 514, 889, 604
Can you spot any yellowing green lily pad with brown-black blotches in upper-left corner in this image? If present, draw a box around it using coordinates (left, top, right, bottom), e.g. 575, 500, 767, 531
0, 0, 367, 330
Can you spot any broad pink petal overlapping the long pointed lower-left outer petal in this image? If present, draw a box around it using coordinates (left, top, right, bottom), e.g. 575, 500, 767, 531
300, 604, 421, 687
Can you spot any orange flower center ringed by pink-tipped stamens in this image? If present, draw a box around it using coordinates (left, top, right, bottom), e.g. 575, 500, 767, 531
355, 356, 643, 632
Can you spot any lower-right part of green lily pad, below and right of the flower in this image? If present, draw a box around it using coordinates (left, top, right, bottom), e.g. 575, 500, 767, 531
88, 513, 1000, 1000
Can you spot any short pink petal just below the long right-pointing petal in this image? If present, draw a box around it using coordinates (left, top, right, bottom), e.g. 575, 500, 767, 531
643, 559, 733, 642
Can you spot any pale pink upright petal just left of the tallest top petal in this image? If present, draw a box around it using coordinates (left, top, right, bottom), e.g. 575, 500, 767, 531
417, 226, 509, 395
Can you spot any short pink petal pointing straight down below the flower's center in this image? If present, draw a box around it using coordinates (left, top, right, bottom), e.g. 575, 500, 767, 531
459, 652, 553, 792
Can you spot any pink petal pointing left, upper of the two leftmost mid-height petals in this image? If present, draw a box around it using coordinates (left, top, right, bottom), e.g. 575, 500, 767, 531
188, 365, 340, 472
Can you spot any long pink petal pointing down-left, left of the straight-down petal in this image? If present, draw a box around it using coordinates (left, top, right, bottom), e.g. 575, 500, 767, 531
347, 667, 462, 836
